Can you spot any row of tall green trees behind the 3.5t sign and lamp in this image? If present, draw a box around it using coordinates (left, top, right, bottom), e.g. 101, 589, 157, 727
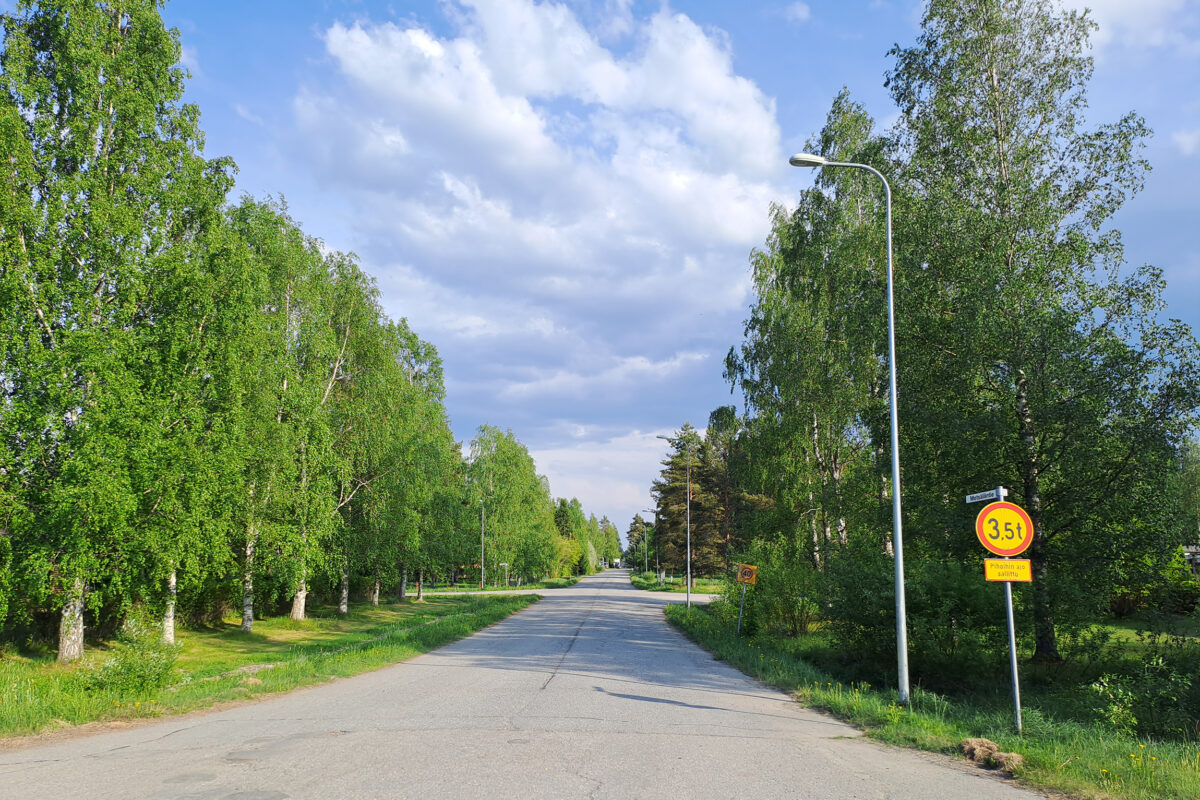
654, 0, 1200, 661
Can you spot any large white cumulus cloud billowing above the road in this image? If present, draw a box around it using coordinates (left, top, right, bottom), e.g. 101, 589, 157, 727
285, 0, 788, 513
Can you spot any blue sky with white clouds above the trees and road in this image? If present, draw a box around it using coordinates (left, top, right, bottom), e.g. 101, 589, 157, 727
37, 0, 1200, 531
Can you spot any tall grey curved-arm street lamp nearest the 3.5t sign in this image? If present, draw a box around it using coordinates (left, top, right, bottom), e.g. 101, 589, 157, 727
788, 152, 908, 703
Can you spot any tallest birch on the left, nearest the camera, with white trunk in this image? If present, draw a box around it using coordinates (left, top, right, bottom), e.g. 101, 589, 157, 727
0, 0, 232, 661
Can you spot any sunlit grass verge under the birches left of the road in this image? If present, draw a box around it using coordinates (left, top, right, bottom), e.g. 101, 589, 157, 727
0, 595, 539, 738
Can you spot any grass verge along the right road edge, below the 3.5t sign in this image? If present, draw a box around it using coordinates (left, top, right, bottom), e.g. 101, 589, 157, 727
666, 606, 1200, 800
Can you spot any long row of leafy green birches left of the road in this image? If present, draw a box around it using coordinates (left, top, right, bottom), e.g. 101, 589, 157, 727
0, 0, 614, 661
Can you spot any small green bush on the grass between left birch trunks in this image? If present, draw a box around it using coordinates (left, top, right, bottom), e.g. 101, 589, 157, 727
79, 615, 180, 694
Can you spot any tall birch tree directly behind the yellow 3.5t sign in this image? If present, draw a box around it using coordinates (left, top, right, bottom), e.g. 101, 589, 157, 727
888, 0, 1200, 660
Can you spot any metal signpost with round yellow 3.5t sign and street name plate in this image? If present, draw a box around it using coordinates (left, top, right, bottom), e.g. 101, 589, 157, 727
967, 486, 1033, 733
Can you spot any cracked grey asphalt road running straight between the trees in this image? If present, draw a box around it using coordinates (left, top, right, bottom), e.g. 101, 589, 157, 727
0, 571, 1040, 800
